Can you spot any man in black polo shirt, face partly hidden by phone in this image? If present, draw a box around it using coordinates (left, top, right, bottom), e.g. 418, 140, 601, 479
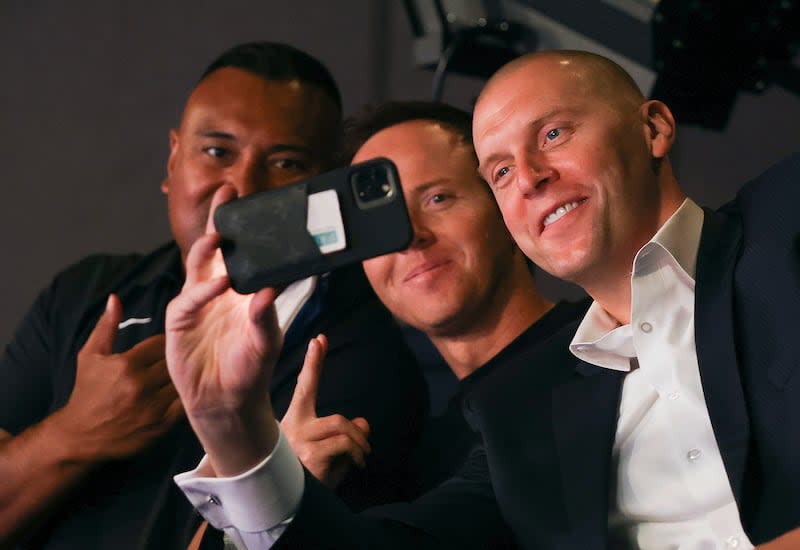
0, 43, 425, 548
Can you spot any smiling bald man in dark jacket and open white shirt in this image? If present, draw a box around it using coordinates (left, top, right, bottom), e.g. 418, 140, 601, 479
167, 52, 800, 550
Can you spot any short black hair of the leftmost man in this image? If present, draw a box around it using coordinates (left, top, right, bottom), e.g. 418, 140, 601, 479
198, 42, 342, 113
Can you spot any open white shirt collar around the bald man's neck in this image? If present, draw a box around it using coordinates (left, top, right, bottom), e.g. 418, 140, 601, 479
569, 198, 703, 371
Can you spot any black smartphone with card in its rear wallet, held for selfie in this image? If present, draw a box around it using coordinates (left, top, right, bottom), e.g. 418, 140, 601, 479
214, 158, 412, 294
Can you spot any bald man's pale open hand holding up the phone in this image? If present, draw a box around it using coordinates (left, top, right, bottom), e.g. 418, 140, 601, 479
166, 186, 282, 475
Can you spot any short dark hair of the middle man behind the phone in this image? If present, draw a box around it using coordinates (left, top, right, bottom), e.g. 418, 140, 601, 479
339, 101, 472, 164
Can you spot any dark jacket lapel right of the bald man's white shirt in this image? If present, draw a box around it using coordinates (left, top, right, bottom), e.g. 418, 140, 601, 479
695, 210, 749, 503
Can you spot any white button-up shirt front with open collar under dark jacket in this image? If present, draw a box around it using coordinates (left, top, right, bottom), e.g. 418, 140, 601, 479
570, 199, 753, 550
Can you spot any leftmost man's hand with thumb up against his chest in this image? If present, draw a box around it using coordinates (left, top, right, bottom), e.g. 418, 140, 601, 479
54, 294, 182, 461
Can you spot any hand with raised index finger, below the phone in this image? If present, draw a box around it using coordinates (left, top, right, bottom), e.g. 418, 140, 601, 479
281, 334, 370, 488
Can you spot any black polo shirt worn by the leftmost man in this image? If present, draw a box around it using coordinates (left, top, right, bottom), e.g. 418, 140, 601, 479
0, 243, 426, 549
